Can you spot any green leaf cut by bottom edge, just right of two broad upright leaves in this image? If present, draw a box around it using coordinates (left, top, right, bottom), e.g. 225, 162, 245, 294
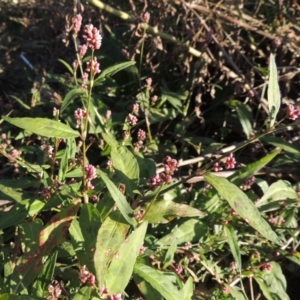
134, 263, 182, 300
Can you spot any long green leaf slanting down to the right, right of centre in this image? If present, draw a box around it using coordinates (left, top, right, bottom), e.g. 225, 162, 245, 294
204, 173, 281, 244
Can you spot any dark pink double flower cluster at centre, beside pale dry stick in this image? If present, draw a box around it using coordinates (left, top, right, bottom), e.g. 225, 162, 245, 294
149, 156, 179, 189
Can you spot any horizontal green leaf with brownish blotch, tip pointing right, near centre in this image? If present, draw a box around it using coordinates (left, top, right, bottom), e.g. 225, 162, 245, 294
144, 199, 206, 223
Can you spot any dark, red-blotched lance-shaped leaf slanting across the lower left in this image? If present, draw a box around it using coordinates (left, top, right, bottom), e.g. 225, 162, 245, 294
11, 204, 79, 293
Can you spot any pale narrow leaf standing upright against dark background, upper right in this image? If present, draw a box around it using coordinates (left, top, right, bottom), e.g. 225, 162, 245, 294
268, 53, 280, 127
